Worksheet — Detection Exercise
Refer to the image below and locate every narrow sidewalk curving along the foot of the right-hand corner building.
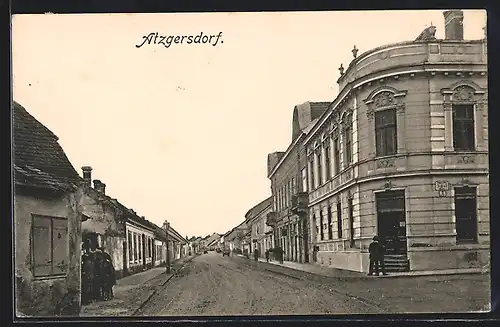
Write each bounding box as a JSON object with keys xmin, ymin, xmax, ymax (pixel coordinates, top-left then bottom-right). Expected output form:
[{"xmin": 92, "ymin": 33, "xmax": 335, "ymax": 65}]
[{"xmin": 246, "ymin": 258, "xmax": 489, "ymax": 278}]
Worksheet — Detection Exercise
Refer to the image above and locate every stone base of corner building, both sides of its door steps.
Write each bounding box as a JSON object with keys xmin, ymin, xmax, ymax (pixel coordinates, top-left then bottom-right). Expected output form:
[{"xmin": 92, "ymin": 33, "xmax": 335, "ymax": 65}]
[{"xmin": 316, "ymin": 245, "xmax": 490, "ymax": 273}]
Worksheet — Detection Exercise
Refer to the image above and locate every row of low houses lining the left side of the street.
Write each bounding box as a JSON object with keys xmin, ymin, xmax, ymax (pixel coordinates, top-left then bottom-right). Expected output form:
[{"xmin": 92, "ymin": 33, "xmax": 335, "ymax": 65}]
[{"xmin": 13, "ymin": 102, "xmax": 188, "ymax": 316}]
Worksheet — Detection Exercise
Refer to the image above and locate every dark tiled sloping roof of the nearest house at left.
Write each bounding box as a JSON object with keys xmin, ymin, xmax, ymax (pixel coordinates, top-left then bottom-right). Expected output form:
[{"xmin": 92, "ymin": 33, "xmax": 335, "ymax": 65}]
[{"xmin": 12, "ymin": 102, "xmax": 82, "ymax": 190}]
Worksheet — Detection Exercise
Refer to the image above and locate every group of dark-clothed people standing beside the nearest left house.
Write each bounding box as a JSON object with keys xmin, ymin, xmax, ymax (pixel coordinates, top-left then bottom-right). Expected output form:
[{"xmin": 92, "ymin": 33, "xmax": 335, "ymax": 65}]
[{"xmin": 82, "ymin": 241, "xmax": 116, "ymax": 305}]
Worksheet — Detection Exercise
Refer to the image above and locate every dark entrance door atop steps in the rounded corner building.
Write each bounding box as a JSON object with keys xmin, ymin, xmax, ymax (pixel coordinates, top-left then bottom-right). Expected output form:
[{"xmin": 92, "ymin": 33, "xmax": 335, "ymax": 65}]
[{"xmin": 377, "ymin": 191, "xmax": 407, "ymax": 255}]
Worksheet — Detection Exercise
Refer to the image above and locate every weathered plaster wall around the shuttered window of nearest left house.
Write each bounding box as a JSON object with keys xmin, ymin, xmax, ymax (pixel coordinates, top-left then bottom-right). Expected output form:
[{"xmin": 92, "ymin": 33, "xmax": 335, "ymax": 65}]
[{"xmin": 14, "ymin": 193, "xmax": 81, "ymax": 317}]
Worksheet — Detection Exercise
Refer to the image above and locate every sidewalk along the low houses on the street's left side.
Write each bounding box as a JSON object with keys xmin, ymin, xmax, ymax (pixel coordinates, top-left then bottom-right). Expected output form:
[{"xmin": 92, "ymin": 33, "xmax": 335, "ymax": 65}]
[{"xmin": 80, "ymin": 256, "xmax": 195, "ymax": 317}]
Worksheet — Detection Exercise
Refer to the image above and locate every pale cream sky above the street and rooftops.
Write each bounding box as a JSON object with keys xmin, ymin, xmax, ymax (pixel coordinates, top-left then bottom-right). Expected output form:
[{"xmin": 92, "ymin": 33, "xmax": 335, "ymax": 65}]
[{"xmin": 12, "ymin": 10, "xmax": 486, "ymax": 237}]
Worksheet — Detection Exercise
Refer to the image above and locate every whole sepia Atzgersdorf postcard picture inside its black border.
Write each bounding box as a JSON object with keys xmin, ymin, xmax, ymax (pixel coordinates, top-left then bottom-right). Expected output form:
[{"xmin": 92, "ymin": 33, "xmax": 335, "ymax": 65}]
[{"xmin": 11, "ymin": 9, "xmax": 491, "ymax": 319}]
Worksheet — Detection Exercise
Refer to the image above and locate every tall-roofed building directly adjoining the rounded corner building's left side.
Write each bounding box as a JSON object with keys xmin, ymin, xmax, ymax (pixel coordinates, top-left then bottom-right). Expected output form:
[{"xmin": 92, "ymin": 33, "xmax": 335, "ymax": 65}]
[{"xmin": 268, "ymin": 102, "xmax": 330, "ymax": 262}]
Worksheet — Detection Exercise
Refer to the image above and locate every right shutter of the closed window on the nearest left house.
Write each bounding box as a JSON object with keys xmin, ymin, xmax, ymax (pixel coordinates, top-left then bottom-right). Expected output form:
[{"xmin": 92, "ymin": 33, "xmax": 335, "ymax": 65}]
[{"xmin": 52, "ymin": 219, "xmax": 69, "ymax": 275}]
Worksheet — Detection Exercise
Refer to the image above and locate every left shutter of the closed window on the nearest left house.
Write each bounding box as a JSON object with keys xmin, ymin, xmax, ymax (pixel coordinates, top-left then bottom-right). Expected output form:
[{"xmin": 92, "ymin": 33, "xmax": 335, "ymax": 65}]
[{"xmin": 32, "ymin": 216, "xmax": 52, "ymax": 277}]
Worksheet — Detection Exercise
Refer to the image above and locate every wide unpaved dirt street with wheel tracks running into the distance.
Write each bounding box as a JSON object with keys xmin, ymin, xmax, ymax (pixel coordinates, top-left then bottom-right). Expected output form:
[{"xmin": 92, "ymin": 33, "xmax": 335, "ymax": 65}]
[{"xmin": 140, "ymin": 252, "xmax": 489, "ymax": 316}]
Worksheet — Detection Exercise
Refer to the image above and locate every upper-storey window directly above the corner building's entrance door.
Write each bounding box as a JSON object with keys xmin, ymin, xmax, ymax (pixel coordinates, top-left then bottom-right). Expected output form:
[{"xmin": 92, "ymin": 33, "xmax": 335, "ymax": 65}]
[{"xmin": 375, "ymin": 109, "xmax": 397, "ymax": 157}]
